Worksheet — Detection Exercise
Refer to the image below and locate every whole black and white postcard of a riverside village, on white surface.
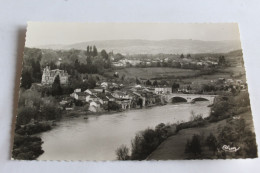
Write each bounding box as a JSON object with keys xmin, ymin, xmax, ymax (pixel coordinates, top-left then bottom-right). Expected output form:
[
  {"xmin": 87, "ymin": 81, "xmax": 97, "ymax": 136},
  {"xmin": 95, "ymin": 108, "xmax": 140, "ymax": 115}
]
[{"xmin": 12, "ymin": 22, "xmax": 258, "ymax": 161}]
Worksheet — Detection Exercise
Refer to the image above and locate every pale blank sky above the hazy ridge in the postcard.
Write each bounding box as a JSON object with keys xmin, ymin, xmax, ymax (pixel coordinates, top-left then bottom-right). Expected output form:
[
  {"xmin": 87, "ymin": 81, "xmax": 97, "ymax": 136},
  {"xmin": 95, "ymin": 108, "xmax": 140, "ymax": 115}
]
[{"xmin": 25, "ymin": 22, "xmax": 240, "ymax": 47}]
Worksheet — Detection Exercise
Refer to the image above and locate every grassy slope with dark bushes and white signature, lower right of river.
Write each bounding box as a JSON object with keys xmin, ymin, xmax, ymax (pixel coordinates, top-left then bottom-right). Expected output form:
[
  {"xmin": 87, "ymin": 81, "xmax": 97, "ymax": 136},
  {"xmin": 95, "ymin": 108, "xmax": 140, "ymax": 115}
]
[{"xmin": 147, "ymin": 93, "xmax": 257, "ymax": 160}]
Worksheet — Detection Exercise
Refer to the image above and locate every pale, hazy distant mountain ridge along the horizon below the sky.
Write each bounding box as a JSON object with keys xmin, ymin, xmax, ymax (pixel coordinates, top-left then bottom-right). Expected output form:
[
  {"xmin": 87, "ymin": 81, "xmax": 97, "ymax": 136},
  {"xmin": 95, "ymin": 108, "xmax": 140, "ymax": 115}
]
[{"xmin": 35, "ymin": 39, "xmax": 241, "ymax": 54}]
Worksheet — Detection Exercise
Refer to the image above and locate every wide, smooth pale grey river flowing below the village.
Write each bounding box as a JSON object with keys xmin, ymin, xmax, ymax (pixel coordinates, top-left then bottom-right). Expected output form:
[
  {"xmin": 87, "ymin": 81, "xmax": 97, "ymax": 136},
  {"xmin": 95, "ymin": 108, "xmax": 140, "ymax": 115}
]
[{"xmin": 38, "ymin": 101, "xmax": 210, "ymax": 160}]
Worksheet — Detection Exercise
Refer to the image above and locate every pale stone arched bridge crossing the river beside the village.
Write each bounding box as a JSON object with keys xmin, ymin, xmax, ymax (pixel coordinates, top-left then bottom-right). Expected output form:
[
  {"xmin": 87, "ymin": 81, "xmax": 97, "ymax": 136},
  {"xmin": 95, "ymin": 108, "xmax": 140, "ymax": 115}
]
[{"xmin": 164, "ymin": 93, "xmax": 216, "ymax": 104}]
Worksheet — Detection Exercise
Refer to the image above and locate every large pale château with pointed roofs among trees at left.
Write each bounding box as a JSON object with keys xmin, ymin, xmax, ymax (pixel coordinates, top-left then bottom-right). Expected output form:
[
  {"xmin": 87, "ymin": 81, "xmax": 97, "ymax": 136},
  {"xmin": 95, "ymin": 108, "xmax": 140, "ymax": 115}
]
[{"xmin": 42, "ymin": 66, "xmax": 69, "ymax": 85}]
